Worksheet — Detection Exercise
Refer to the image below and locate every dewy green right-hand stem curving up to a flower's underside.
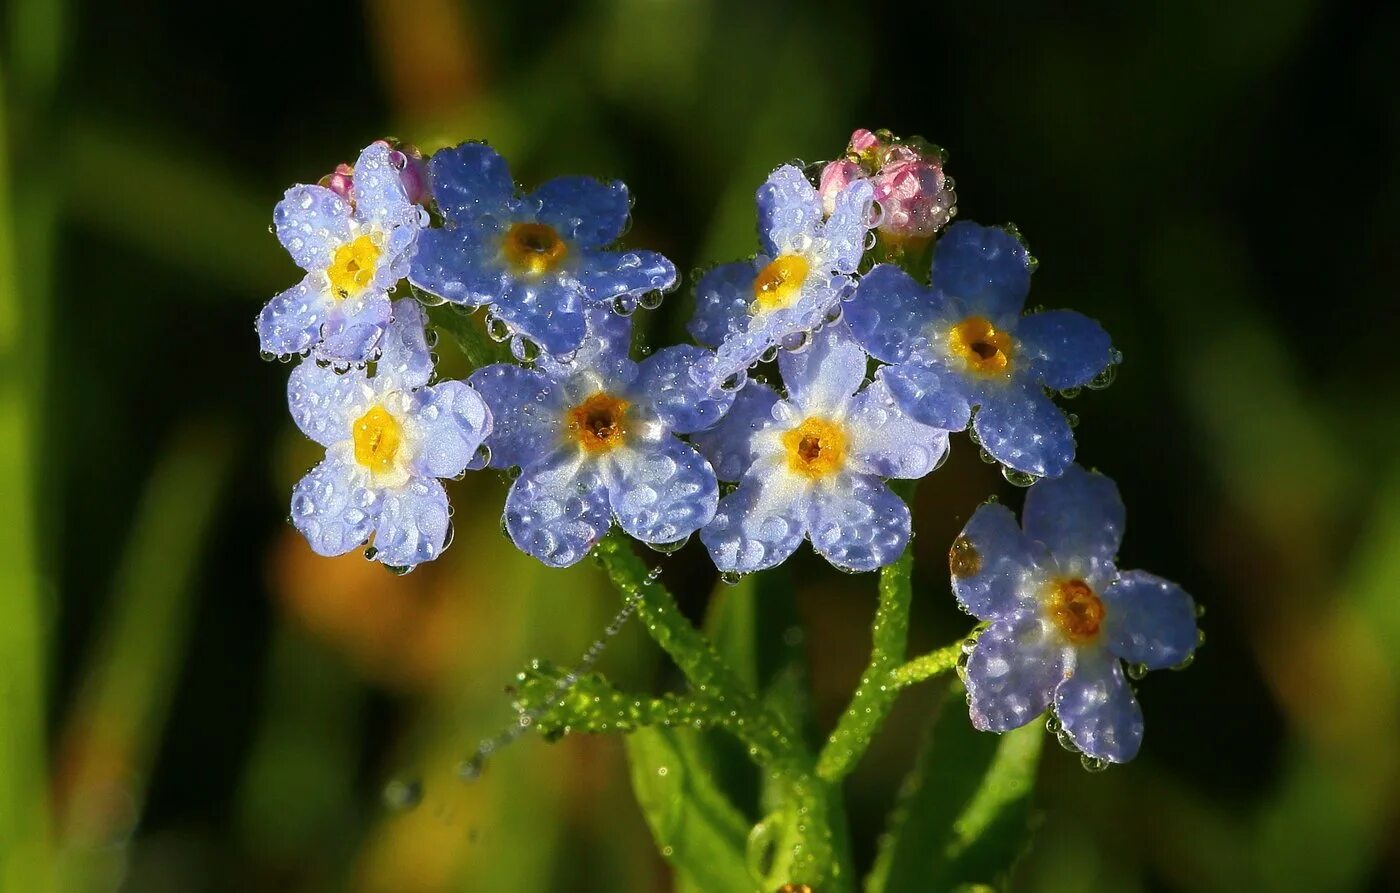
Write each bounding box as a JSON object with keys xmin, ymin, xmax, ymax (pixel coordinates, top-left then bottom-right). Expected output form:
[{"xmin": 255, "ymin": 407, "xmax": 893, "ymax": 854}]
[{"xmin": 816, "ymin": 549, "xmax": 914, "ymax": 782}]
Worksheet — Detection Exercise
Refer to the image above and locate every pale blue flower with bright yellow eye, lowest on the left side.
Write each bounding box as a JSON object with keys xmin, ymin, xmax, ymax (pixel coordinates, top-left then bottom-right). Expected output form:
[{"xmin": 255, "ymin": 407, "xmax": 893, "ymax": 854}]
[{"xmin": 287, "ymin": 296, "xmax": 491, "ymax": 567}]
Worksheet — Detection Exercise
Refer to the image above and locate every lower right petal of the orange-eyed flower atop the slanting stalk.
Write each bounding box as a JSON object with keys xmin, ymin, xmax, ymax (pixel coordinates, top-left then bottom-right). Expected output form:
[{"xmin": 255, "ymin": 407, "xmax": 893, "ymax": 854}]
[{"xmin": 608, "ymin": 437, "xmax": 720, "ymax": 543}]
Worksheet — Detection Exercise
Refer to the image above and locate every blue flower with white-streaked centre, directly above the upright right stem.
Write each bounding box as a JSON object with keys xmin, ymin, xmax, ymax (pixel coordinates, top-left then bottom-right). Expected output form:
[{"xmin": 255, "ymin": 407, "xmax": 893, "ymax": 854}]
[{"xmin": 693, "ymin": 322, "xmax": 948, "ymax": 572}]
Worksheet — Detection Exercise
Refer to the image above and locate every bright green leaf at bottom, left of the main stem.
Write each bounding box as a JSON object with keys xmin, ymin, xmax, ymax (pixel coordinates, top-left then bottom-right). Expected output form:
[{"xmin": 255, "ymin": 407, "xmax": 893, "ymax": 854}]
[{"xmin": 626, "ymin": 728, "xmax": 756, "ymax": 893}]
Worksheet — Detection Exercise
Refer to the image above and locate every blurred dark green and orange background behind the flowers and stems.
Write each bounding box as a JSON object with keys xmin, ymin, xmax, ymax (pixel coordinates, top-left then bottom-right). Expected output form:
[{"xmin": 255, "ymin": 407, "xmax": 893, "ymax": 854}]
[{"xmin": 0, "ymin": 0, "xmax": 1400, "ymax": 893}]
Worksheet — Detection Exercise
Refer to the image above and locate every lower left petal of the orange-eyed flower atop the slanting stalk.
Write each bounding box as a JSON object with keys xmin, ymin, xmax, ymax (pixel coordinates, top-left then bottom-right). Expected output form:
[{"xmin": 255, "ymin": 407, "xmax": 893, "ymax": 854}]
[{"xmin": 505, "ymin": 448, "xmax": 612, "ymax": 567}]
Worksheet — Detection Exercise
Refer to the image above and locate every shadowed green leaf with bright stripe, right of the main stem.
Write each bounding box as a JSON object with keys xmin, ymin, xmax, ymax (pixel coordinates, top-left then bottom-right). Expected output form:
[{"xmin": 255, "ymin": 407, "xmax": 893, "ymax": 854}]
[{"xmin": 865, "ymin": 686, "xmax": 1046, "ymax": 893}]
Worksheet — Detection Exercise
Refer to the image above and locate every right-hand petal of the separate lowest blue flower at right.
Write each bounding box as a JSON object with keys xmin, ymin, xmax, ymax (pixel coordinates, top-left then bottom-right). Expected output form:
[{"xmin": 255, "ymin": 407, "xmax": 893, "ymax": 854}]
[{"xmin": 1103, "ymin": 571, "xmax": 1197, "ymax": 669}]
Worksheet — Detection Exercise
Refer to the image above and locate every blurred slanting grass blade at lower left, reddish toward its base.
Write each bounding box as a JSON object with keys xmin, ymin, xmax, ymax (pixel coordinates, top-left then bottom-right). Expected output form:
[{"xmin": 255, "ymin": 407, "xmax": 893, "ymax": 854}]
[{"xmin": 56, "ymin": 424, "xmax": 232, "ymax": 890}]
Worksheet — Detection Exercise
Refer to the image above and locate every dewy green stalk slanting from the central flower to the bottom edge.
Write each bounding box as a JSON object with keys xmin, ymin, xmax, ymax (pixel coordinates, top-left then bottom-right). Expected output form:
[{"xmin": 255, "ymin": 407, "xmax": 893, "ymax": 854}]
[{"xmin": 594, "ymin": 530, "xmax": 853, "ymax": 893}]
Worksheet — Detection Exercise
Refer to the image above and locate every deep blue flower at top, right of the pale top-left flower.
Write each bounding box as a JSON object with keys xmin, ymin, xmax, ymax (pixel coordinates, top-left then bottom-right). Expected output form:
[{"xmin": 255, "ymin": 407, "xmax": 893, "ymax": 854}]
[{"xmin": 409, "ymin": 143, "xmax": 676, "ymax": 354}]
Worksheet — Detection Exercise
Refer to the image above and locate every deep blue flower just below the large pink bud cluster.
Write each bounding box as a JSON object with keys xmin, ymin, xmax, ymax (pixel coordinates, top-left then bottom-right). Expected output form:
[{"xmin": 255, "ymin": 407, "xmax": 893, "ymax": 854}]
[{"xmin": 844, "ymin": 223, "xmax": 1114, "ymax": 477}]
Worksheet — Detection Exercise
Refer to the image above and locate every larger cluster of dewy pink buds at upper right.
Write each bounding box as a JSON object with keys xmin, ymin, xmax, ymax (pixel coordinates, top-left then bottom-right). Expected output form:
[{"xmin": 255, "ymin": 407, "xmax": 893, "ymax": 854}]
[{"xmin": 820, "ymin": 129, "xmax": 958, "ymax": 248}]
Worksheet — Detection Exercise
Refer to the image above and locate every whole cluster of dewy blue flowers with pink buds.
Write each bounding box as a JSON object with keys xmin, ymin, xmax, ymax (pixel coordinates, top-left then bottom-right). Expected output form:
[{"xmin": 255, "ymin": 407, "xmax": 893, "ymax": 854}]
[{"xmin": 256, "ymin": 130, "xmax": 1196, "ymax": 760}]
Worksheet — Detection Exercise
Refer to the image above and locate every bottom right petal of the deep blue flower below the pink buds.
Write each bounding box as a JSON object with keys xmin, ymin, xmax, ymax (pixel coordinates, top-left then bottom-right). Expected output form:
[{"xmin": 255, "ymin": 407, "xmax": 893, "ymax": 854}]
[{"xmin": 973, "ymin": 382, "xmax": 1074, "ymax": 477}]
